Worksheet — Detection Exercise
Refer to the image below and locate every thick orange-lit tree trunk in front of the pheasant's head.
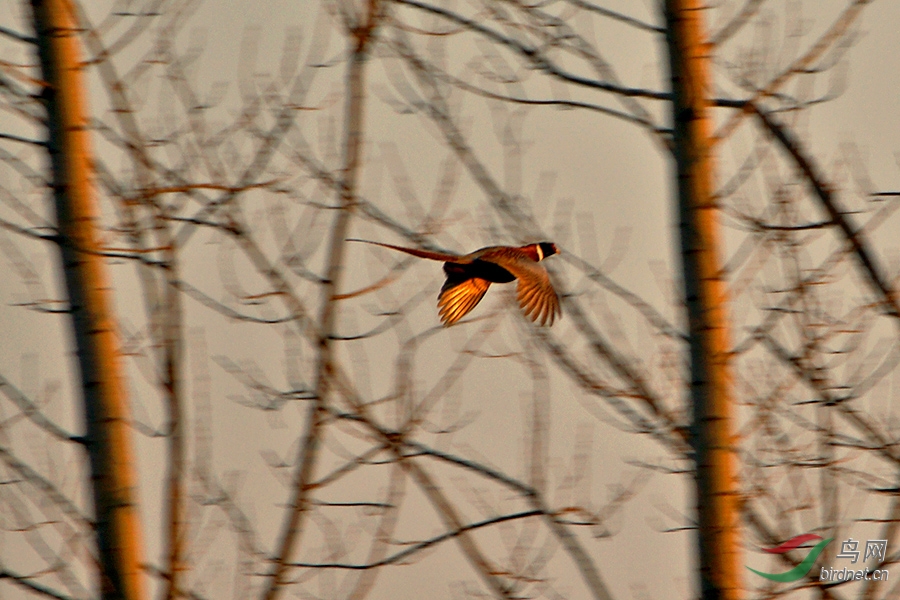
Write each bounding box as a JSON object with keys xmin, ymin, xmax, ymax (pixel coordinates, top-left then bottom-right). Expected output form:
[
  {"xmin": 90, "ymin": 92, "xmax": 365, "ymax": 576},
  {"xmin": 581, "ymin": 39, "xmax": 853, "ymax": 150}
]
[{"xmin": 665, "ymin": 0, "xmax": 741, "ymax": 600}]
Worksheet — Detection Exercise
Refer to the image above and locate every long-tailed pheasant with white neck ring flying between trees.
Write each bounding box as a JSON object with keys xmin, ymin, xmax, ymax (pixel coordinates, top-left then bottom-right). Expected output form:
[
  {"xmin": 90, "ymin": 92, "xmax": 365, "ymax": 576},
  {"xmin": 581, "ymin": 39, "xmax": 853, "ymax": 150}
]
[{"xmin": 347, "ymin": 239, "xmax": 562, "ymax": 327}]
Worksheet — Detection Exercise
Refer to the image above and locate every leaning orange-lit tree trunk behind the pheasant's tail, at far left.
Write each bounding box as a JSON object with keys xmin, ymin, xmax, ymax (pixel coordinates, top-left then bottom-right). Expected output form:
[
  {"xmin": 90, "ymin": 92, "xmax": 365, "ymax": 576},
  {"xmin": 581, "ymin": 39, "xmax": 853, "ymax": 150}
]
[{"xmin": 31, "ymin": 0, "xmax": 145, "ymax": 599}]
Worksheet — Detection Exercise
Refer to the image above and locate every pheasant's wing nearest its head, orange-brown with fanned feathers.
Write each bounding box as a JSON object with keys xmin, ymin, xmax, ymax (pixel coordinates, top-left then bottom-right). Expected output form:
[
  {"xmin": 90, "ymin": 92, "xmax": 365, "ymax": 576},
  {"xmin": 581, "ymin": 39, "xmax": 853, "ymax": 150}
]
[{"xmin": 480, "ymin": 249, "xmax": 562, "ymax": 325}]
